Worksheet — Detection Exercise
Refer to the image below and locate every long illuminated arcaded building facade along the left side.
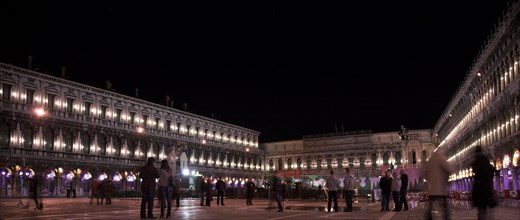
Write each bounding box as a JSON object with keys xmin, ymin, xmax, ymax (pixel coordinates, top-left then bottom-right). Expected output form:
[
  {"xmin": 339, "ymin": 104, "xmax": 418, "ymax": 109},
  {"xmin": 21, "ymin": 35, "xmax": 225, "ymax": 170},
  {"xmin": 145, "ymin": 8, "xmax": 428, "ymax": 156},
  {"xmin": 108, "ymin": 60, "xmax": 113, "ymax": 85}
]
[{"xmin": 0, "ymin": 63, "xmax": 265, "ymax": 197}]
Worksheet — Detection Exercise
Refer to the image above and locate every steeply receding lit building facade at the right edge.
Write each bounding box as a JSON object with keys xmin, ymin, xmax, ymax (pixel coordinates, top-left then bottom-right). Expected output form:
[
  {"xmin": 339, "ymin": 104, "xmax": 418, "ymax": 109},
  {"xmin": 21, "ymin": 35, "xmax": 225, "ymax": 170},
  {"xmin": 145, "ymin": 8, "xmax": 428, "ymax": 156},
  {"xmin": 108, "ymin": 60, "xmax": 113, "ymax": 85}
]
[{"xmin": 433, "ymin": 1, "xmax": 520, "ymax": 192}]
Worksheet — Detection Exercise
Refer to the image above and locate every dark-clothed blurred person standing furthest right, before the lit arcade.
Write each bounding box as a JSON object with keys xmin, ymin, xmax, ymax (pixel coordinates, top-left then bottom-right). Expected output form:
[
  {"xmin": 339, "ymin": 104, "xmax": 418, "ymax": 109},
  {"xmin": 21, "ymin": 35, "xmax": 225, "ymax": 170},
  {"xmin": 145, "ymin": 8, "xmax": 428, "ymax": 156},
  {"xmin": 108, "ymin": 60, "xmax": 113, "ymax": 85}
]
[{"xmin": 471, "ymin": 146, "xmax": 496, "ymax": 220}]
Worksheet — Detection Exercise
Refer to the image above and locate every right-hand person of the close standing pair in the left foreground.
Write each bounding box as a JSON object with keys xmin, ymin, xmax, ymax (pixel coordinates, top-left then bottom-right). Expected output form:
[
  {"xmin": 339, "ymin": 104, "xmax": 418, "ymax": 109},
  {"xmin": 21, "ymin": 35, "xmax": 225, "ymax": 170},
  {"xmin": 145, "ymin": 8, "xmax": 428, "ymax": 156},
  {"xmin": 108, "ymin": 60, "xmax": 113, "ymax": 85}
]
[{"xmin": 158, "ymin": 159, "xmax": 175, "ymax": 218}]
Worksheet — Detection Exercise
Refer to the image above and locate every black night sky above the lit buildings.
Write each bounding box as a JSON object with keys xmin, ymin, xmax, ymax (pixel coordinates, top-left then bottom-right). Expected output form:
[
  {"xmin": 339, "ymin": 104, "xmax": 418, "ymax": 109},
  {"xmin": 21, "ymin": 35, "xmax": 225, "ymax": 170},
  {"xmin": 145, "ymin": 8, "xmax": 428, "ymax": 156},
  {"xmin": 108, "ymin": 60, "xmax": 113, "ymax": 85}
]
[{"xmin": 0, "ymin": 0, "xmax": 506, "ymax": 142}]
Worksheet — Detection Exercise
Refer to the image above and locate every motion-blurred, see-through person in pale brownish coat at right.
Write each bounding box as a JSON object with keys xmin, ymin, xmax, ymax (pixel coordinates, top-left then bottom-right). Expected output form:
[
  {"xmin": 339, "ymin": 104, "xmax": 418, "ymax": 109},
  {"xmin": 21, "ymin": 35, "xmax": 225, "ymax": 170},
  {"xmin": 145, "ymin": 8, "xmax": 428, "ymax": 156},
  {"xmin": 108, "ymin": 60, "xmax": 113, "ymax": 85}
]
[{"xmin": 424, "ymin": 148, "xmax": 453, "ymax": 220}]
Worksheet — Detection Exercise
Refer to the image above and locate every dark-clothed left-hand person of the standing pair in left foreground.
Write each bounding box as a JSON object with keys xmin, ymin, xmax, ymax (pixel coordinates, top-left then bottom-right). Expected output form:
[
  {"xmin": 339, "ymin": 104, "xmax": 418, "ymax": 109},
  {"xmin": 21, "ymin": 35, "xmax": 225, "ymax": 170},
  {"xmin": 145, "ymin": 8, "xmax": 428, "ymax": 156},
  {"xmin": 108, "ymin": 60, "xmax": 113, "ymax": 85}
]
[{"xmin": 139, "ymin": 157, "xmax": 159, "ymax": 218}]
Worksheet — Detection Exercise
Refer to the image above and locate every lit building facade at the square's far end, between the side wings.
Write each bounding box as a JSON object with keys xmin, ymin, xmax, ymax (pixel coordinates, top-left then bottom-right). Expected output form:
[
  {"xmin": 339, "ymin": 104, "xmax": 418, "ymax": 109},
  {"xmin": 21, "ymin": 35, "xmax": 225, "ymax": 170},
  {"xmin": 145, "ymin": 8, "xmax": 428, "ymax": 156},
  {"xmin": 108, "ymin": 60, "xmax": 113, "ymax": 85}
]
[{"xmin": 261, "ymin": 127, "xmax": 435, "ymax": 190}]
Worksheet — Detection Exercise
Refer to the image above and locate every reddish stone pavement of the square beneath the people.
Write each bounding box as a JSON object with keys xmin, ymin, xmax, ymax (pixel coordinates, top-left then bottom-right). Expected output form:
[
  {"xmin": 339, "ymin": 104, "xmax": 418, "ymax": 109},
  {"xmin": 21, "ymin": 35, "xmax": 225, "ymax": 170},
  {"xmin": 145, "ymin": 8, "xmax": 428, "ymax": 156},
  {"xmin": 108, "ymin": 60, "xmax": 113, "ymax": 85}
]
[{"xmin": 0, "ymin": 198, "xmax": 520, "ymax": 220}]
